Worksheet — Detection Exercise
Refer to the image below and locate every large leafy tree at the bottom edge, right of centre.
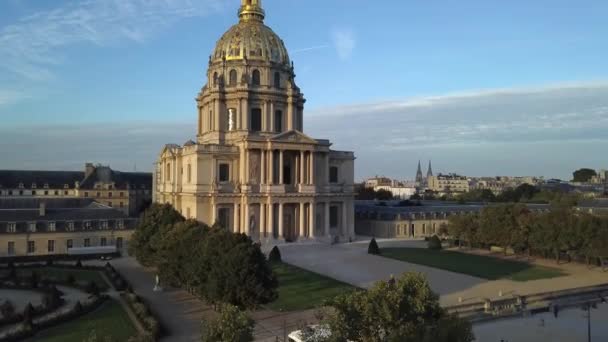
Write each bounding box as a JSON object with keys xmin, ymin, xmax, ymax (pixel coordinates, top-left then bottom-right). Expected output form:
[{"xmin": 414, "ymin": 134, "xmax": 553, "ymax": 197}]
[{"xmin": 326, "ymin": 273, "xmax": 474, "ymax": 342}]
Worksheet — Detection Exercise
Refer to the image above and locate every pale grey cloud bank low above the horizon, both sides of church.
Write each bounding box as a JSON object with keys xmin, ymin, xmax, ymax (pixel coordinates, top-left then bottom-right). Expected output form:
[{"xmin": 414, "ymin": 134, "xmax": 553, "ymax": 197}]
[{"xmin": 0, "ymin": 82, "xmax": 608, "ymax": 178}]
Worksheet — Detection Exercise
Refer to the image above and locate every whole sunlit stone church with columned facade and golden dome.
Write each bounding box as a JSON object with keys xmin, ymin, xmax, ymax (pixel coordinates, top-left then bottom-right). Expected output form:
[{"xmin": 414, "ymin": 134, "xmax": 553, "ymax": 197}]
[{"xmin": 153, "ymin": 0, "xmax": 355, "ymax": 242}]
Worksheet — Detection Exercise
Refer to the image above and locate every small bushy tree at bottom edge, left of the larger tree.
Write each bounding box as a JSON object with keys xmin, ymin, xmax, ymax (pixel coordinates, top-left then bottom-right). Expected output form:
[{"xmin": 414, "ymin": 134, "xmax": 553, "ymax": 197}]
[{"xmin": 201, "ymin": 305, "xmax": 254, "ymax": 342}]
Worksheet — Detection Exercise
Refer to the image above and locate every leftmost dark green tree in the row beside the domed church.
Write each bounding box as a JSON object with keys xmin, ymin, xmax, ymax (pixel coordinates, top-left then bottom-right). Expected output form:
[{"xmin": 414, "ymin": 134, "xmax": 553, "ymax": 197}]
[{"xmin": 129, "ymin": 203, "xmax": 185, "ymax": 266}]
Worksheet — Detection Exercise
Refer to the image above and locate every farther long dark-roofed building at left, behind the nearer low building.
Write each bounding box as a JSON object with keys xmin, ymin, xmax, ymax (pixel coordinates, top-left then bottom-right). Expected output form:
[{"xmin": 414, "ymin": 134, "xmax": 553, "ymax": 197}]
[{"xmin": 0, "ymin": 163, "xmax": 152, "ymax": 216}]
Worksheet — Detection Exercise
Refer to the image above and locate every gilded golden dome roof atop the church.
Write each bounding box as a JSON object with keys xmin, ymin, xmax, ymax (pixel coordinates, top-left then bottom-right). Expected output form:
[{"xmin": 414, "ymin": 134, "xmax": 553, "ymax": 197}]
[{"xmin": 211, "ymin": 0, "xmax": 289, "ymax": 66}]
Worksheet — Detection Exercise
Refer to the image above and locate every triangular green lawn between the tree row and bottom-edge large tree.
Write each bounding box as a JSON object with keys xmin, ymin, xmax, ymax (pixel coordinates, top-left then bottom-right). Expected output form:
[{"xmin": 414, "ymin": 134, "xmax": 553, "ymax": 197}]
[{"xmin": 268, "ymin": 263, "xmax": 355, "ymax": 311}]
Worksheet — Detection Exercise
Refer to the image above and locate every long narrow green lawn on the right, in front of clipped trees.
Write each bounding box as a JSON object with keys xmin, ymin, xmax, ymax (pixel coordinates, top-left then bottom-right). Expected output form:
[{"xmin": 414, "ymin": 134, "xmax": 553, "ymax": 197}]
[{"xmin": 381, "ymin": 248, "xmax": 567, "ymax": 281}]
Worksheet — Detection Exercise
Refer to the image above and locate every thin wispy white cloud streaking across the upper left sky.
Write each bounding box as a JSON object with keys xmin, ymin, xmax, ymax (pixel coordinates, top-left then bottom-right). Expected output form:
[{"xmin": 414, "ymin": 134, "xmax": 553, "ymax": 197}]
[{"xmin": 0, "ymin": 0, "xmax": 223, "ymax": 81}]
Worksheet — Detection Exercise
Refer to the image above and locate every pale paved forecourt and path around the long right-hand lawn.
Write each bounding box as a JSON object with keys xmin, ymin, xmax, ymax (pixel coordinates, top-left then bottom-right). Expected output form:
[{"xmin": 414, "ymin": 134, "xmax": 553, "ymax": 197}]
[{"xmin": 279, "ymin": 240, "xmax": 608, "ymax": 306}]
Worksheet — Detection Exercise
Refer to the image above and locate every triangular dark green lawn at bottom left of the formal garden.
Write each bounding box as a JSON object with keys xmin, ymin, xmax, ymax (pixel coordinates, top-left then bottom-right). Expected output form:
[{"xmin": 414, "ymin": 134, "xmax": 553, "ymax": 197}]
[{"xmin": 33, "ymin": 300, "xmax": 137, "ymax": 342}]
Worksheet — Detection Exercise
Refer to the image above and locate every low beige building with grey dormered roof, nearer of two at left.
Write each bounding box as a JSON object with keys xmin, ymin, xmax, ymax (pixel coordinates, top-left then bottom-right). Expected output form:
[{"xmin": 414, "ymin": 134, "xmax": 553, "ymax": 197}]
[{"xmin": 0, "ymin": 196, "xmax": 137, "ymax": 257}]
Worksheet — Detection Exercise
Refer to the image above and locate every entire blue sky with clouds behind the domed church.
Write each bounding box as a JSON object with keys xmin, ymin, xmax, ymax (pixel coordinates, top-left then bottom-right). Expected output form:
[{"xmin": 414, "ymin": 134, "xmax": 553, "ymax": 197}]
[{"xmin": 0, "ymin": 0, "xmax": 608, "ymax": 178}]
